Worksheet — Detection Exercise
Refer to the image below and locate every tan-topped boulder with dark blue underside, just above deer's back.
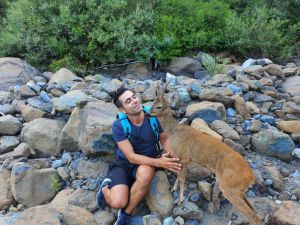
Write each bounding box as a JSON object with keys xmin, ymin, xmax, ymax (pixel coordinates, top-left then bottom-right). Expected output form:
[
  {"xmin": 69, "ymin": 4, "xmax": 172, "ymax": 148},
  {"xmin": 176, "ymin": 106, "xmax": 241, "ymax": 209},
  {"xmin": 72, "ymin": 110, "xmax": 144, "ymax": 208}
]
[{"xmin": 186, "ymin": 101, "xmax": 226, "ymax": 124}]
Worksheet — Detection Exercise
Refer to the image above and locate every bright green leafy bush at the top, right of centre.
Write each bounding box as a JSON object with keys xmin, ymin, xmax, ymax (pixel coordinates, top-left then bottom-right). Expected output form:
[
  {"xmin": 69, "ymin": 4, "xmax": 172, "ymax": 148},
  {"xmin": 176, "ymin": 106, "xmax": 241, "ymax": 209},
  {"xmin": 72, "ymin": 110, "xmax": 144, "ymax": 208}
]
[{"xmin": 154, "ymin": 0, "xmax": 231, "ymax": 60}]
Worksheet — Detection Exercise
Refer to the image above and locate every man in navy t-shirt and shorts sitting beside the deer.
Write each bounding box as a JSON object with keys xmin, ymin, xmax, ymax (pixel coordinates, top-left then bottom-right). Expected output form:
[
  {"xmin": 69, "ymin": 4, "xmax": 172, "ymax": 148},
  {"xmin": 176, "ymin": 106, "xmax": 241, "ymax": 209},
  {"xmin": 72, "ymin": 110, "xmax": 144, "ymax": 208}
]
[{"xmin": 97, "ymin": 87, "xmax": 181, "ymax": 225}]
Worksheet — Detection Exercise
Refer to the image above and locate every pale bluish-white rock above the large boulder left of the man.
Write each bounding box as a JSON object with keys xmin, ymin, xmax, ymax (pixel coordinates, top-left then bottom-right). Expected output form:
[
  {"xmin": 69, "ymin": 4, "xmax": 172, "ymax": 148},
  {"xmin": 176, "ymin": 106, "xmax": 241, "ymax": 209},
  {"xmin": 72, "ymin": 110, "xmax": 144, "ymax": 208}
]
[{"xmin": 52, "ymin": 90, "xmax": 87, "ymax": 113}]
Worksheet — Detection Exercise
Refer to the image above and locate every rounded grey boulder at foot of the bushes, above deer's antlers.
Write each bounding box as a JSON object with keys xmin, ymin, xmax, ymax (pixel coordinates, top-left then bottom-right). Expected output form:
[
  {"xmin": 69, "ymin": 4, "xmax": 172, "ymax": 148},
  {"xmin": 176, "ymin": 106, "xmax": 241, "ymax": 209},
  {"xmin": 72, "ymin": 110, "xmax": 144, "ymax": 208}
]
[{"xmin": 167, "ymin": 57, "xmax": 202, "ymax": 77}]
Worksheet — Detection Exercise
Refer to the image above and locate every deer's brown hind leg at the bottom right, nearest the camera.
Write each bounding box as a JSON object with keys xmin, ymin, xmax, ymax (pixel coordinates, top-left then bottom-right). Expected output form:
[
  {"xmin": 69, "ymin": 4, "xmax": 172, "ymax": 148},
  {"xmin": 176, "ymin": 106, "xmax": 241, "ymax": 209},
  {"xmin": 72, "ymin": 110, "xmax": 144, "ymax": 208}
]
[{"xmin": 222, "ymin": 190, "xmax": 262, "ymax": 225}]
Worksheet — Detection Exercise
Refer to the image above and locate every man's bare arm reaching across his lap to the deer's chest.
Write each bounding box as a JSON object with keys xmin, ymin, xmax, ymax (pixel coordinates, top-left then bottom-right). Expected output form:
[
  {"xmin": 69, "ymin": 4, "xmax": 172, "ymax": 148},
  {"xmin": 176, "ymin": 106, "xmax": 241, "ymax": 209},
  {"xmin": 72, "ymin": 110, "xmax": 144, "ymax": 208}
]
[{"xmin": 117, "ymin": 139, "xmax": 181, "ymax": 174}]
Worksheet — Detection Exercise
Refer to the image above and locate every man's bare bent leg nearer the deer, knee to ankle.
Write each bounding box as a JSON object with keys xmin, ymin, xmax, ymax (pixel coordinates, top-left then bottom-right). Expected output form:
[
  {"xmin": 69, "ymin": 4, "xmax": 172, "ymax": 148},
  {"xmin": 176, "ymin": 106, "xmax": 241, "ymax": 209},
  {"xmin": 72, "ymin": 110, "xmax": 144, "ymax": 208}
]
[{"xmin": 125, "ymin": 165, "xmax": 155, "ymax": 214}]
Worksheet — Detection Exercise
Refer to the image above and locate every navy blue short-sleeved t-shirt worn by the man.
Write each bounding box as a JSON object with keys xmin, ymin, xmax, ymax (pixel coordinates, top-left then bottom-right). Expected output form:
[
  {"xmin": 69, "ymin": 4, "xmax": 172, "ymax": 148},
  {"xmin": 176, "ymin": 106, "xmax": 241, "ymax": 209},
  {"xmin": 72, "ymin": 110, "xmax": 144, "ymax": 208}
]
[{"xmin": 112, "ymin": 117, "xmax": 163, "ymax": 158}]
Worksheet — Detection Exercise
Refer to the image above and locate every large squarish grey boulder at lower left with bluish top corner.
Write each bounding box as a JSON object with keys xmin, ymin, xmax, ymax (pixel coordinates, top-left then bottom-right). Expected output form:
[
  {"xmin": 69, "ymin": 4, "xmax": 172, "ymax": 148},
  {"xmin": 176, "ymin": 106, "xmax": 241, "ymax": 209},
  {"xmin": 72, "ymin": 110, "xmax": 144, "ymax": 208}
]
[{"xmin": 11, "ymin": 163, "xmax": 57, "ymax": 207}]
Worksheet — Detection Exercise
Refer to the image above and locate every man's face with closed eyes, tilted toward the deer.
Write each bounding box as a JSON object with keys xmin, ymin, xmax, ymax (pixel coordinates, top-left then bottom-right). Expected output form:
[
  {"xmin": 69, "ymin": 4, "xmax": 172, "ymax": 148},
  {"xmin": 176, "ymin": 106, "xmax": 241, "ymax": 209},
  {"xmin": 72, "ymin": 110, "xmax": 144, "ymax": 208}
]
[{"xmin": 119, "ymin": 91, "xmax": 143, "ymax": 115}]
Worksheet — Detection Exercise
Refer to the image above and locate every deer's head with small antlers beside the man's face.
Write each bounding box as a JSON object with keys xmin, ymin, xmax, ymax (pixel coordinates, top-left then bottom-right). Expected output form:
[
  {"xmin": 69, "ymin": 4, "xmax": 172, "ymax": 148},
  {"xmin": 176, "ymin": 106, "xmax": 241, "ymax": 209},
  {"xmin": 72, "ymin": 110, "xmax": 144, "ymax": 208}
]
[{"xmin": 150, "ymin": 81, "xmax": 170, "ymax": 117}]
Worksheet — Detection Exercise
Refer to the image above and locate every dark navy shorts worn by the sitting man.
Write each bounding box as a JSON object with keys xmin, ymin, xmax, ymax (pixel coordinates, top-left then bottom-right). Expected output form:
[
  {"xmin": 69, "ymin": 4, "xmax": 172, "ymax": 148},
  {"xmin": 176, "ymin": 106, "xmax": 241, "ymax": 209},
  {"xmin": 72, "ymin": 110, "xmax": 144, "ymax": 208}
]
[{"xmin": 108, "ymin": 159, "xmax": 139, "ymax": 189}]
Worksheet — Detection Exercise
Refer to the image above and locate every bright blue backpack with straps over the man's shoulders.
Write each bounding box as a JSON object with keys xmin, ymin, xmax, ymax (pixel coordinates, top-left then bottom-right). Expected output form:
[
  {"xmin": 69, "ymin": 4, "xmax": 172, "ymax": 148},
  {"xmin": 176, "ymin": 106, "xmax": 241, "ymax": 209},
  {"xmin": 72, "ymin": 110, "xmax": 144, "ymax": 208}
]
[{"xmin": 117, "ymin": 106, "xmax": 160, "ymax": 159}]
